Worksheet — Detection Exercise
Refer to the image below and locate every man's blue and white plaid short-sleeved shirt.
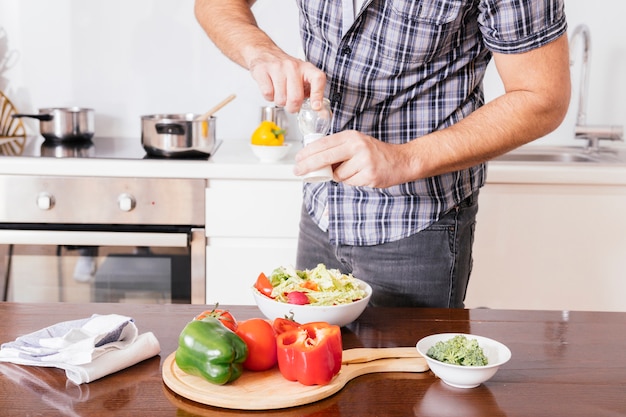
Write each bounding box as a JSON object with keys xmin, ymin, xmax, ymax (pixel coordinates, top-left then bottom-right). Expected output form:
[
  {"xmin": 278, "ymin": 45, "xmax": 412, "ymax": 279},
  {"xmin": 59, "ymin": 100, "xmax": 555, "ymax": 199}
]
[{"xmin": 297, "ymin": 0, "xmax": 567, "ymax": 246}]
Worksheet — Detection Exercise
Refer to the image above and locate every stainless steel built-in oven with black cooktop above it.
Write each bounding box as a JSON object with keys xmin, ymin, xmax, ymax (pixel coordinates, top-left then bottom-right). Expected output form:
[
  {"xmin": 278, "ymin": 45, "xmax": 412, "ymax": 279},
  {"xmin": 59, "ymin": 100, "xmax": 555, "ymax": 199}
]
[{"xmin": 0, "ymin": 138, "xmax": 206, "ymax": 304}]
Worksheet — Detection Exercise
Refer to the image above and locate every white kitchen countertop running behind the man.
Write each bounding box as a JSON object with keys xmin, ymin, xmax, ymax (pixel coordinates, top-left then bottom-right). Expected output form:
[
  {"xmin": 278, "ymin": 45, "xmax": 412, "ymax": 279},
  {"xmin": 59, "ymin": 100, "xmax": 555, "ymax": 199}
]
[{"xmin": 0, "ymin": 139, "xmax": 626, "ymax": 185}]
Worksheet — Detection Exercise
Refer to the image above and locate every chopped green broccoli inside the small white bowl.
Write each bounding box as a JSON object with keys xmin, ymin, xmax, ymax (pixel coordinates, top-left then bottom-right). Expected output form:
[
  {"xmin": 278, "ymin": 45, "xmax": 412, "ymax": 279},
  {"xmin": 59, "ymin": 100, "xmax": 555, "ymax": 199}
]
[{"xmin": 426, "ymin": 335, "xmax": 488, "ymax": 366}]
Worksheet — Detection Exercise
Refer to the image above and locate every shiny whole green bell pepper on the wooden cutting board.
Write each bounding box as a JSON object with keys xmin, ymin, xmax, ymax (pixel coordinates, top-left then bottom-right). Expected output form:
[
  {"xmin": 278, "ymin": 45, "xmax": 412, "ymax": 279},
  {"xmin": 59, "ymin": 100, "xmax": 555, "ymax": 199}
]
[{"xmin": 175, "ymin": 317, "xmax": 248, "ymax": 385}]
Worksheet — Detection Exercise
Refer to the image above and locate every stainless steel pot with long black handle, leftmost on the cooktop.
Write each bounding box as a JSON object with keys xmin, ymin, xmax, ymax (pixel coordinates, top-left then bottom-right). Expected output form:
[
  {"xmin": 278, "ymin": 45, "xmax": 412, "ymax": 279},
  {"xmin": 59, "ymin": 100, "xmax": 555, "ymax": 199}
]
[{"xmin": 13, "ymin": 107, "xmax": 95, "ymax": 142}]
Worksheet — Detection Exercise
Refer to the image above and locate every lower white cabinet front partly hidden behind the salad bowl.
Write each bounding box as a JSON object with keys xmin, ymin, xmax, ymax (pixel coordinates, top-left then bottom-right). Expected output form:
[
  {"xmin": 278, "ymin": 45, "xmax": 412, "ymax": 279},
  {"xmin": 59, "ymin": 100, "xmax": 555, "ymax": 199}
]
[{"xmin": 206, "ymin": 238, "xmax": 297, "ymax": 305}]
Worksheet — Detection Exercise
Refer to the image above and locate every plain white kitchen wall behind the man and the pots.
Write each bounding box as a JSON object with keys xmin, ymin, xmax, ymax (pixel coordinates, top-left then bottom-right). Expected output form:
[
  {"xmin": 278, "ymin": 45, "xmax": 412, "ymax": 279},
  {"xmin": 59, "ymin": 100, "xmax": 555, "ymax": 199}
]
[{"xmin": 0, "ymin": 0, "xmax": 626, "ymax": 147}]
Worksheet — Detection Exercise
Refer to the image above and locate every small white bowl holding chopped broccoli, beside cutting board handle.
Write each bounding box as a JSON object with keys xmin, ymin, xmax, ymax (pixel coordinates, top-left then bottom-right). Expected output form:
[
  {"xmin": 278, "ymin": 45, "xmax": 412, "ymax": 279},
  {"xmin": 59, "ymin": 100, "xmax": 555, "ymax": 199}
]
[{"xmin": 416, "ymin": 333, "xmax": 511, "ymax": 388}]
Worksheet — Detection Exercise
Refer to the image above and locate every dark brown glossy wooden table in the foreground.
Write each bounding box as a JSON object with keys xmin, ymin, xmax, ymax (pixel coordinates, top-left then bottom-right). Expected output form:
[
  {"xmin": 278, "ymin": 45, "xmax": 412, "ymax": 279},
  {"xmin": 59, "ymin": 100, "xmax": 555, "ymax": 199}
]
[{"xmin": 0, "ymin": 303, "xmax": 626, "ymax": 417}]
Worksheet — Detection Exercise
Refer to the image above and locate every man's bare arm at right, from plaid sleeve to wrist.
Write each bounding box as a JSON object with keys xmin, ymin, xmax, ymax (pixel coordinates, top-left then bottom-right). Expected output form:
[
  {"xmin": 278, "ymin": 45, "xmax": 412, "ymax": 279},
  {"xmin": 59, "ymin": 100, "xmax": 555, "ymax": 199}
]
[{"xmin": 400, "ymin": 35, "xmax": 570, "ymax": 183}]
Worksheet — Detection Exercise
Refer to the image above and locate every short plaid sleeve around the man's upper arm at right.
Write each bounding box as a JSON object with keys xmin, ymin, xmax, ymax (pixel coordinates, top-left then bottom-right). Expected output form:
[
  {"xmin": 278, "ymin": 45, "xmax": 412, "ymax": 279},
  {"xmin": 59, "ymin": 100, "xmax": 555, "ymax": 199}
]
[{"xmin": 478, "ymin": 0, "xmax": 567, "ymax": 54}]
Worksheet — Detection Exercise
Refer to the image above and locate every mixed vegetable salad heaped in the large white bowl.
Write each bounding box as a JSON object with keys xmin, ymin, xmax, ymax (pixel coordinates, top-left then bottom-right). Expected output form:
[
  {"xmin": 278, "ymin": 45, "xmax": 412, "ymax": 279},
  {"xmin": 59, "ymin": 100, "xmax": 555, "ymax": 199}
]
[{"xmin": 258, "ymin": 264, "xmax": 367, "ymax": 306}]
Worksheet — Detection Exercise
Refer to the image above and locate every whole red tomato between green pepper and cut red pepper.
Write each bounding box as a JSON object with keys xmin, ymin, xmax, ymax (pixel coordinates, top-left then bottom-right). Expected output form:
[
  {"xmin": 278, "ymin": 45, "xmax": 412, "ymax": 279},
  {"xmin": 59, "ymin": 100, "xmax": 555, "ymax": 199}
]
[{"xmin": 236, "ymin": 318, "xmax": 278, "ymax": 371}]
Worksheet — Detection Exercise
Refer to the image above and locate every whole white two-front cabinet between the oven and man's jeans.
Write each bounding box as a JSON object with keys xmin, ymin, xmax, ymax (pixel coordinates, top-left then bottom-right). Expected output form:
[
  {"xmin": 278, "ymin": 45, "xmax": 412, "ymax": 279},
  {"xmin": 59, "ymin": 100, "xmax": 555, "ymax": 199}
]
[{"xmin": 206, "ymin": 179, "xmax": 302, "ymax": 304}]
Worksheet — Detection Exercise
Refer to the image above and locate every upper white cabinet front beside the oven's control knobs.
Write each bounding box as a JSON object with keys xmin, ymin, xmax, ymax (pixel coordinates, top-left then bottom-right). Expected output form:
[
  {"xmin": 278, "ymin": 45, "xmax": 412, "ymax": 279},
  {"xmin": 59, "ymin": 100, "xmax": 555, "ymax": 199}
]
[{"xmin": 206, "ymin": 180, "xmax": 302, "ymax": 238}]
